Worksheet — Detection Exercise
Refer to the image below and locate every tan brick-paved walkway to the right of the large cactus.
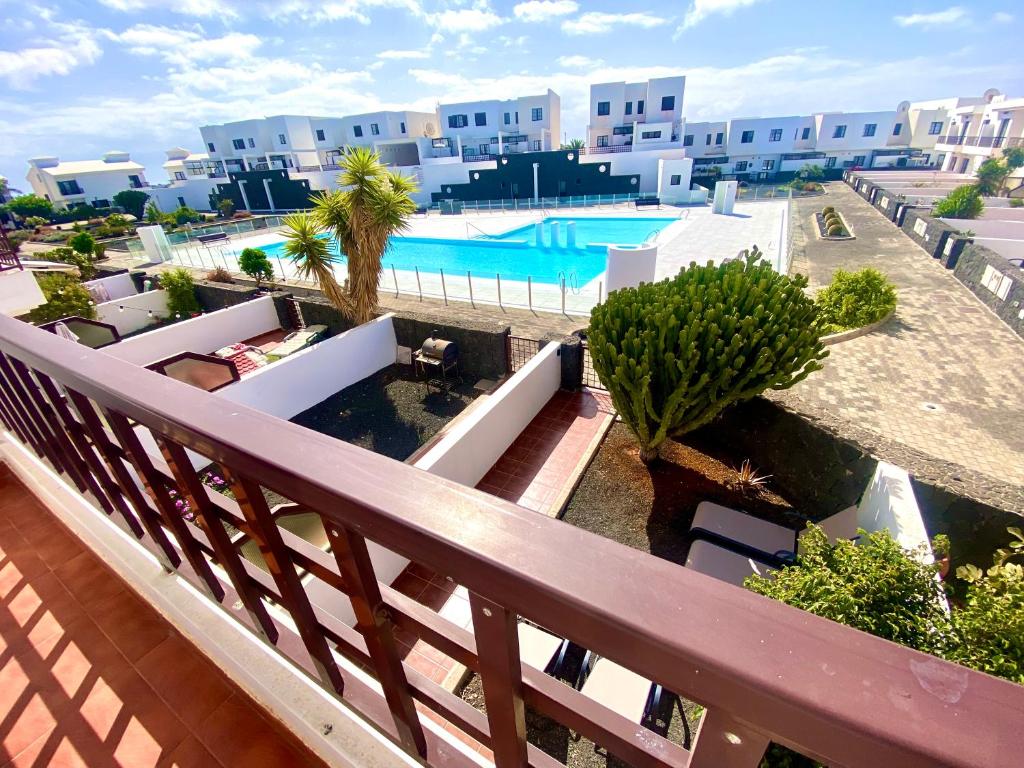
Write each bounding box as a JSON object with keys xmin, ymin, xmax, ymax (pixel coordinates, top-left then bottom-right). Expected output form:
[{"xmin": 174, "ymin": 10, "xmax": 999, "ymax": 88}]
[{"xmin": 784, "ymin": 182, "xmax": 1024, "ymax": 484}]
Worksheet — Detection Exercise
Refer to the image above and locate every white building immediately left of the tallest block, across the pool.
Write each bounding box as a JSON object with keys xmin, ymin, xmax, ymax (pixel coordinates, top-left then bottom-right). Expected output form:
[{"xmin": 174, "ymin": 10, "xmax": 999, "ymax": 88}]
[{"xmin": 436, "ymin": 88, "xmax": 562, "ymax": 160}]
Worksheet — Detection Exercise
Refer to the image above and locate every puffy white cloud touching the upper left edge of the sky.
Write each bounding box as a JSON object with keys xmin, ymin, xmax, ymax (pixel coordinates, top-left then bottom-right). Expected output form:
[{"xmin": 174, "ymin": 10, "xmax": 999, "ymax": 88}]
[{"xmin": 0, "ymin": 19, "xmax": 103, "ymax": 90}]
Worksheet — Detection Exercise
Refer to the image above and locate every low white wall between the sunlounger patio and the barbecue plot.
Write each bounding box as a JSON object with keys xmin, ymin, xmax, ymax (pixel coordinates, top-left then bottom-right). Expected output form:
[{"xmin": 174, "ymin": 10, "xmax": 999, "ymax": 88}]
[{"xmin": 222, "ymin": 314, "xmax": 398, "ymax": 419}]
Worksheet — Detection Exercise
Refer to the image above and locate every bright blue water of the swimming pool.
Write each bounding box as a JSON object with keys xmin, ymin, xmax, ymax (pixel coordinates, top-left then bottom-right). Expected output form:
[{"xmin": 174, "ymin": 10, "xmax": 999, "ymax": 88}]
[{"xmin": 247, "ymin": 217, "xmax": 672, "ymax": 285}]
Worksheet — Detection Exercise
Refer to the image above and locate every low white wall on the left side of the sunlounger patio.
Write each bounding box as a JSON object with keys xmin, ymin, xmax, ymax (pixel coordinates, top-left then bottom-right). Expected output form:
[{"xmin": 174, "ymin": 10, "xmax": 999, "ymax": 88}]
[{"xmin": 102, "ymin": 294, "xmax": 281, "ymax": 366}]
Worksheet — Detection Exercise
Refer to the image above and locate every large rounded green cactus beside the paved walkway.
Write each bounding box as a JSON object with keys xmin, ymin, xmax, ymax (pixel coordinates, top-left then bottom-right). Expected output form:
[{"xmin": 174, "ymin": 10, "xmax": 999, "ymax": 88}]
[{"xmin": 588, "ymin": 246, "xmax": 827, "ymax": 462}]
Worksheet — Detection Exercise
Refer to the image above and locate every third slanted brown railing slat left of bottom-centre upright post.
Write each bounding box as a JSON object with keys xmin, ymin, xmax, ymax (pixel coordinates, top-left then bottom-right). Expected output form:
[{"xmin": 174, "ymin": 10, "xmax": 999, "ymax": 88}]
[{"xmin": 154, "ymin": 434, "xmax": 278, "ymax": 643}]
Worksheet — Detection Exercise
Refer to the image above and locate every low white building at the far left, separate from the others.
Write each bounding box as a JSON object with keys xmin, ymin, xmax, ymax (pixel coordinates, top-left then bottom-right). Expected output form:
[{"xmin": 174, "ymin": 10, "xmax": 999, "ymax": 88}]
[{"xmin": 26, "ymin": 152, "xmax": 146, "ymax": 208}]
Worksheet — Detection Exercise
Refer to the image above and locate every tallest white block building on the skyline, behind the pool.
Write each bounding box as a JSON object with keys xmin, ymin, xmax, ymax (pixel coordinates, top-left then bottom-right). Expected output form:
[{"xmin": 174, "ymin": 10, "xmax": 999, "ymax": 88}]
[{"xmin": 587, "ymin": 76, "xmax": 686, "ymax": 154}]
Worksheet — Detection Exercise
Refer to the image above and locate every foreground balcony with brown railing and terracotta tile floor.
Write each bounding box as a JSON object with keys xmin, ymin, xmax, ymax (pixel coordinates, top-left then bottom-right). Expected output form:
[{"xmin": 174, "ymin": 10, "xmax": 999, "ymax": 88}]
[{"xmin": 0, "ymin": 317, "xmax": 1024, "ymax": 768}]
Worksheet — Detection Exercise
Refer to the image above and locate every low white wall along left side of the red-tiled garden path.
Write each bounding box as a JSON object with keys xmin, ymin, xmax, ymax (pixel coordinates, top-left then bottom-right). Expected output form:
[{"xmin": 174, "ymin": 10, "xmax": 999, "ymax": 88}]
[{"xmin": 415, "ymin": 344, "xmax": 561, "ymax": 486}]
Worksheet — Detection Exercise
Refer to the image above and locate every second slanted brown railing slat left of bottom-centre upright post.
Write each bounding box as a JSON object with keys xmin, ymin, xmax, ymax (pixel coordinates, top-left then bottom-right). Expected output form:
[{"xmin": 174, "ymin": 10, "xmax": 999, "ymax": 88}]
[{"xmin": 222, "ymin": 467, "xmax": 345, "ymax": 693}]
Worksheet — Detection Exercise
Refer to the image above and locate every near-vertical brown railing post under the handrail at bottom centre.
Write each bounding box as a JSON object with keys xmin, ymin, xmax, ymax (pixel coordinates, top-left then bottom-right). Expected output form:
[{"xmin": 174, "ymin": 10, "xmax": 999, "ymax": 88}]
[{"xmin": 469, "ymin": 592, "xmax": 526, "ymax": 768}]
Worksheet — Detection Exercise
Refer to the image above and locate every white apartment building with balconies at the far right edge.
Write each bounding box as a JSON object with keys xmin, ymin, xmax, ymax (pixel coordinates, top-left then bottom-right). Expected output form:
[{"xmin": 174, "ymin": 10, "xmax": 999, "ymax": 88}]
[{"xmin": 935, "ymin": 88, "xmax": 1024, "ymax": 177}]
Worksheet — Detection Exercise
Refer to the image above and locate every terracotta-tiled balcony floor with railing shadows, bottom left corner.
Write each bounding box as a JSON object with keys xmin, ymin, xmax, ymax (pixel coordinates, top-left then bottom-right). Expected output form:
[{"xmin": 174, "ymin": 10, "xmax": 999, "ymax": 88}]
[{"xmin": 0, "ymin": 464, "xmax": 324, "ymax": 768}]
